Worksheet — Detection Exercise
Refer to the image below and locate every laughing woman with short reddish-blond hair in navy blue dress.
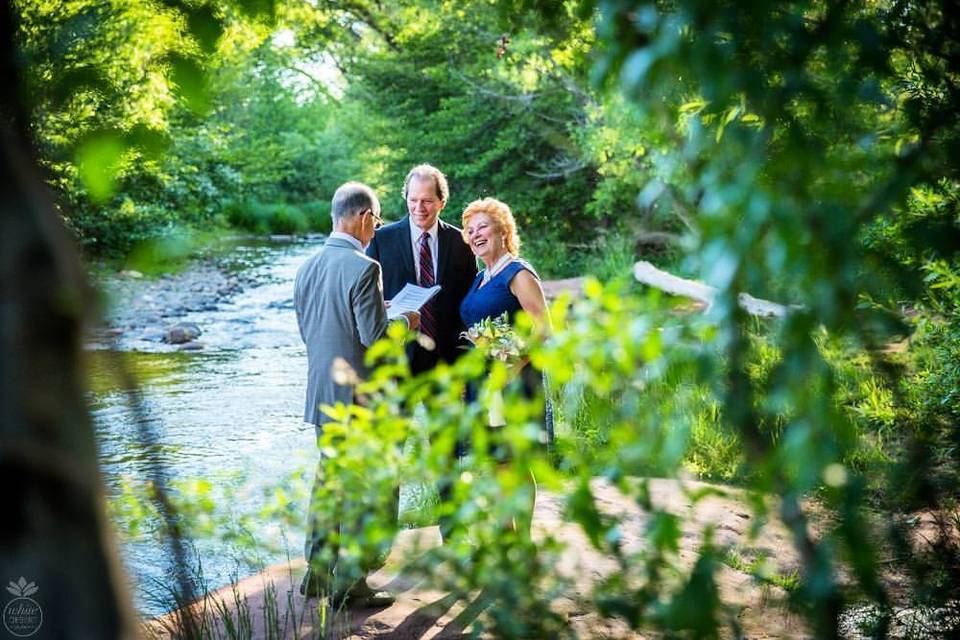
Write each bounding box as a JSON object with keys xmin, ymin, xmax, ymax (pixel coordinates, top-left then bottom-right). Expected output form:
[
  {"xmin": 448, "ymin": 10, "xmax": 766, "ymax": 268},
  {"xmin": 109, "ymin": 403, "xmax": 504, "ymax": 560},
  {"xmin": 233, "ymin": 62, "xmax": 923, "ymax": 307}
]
[{"xmin": 460, "ymin": 198, "xmax": 553, "ymax": 535}]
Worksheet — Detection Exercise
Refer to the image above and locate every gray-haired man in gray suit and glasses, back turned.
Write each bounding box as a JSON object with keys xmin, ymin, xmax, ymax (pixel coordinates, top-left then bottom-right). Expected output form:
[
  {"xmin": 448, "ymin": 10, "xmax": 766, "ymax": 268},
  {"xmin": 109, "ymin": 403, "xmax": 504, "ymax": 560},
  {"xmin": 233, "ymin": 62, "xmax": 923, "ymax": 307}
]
[{"xmin": 293, "ymin": 182, "xmax": 420, "ymax": 606}]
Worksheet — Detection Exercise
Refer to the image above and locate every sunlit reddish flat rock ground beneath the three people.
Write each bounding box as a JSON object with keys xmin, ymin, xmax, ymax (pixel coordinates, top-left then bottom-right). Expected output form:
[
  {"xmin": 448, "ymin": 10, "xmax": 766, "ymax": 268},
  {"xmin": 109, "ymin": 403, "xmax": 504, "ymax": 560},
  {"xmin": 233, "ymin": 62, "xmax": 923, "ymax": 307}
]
[{"xmin": 148, "ymin": 479, "xmax": 809, "ymax": 638}]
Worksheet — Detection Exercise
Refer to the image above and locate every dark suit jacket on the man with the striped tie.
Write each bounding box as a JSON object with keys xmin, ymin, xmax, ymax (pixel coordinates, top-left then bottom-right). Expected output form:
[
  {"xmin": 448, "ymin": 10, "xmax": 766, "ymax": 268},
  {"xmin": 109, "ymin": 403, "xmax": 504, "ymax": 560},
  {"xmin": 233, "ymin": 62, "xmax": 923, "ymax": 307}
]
[{"xmin": 367, "ymin": 216, "xmax": 477, "ymax": 374}]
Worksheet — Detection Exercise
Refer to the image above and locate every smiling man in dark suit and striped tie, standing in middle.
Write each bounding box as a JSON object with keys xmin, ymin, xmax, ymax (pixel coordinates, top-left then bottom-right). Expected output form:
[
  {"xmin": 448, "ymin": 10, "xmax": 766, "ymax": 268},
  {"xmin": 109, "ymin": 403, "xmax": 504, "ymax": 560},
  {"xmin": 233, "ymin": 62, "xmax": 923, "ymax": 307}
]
[{"xmin": 367, "ymin": 164, "xmax": 477, "ymax": 375}]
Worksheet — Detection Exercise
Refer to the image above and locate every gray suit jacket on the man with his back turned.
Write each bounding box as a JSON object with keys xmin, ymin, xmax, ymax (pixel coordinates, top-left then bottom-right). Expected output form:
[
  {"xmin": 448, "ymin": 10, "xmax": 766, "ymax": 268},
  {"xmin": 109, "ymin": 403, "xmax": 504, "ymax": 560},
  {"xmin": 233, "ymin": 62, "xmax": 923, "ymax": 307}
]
[{"xmin": 293, "ymin": 238, "xmax": 387, "ymax": 426}]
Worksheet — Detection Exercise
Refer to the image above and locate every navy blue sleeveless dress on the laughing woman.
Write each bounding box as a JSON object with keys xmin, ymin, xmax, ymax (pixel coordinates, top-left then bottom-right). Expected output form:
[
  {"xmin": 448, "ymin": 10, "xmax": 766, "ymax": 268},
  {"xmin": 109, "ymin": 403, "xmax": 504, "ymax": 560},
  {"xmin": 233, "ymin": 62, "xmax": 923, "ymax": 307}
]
[{"xmin": 460, "ymin": 259, "xmax": 553, "ymax": 443}]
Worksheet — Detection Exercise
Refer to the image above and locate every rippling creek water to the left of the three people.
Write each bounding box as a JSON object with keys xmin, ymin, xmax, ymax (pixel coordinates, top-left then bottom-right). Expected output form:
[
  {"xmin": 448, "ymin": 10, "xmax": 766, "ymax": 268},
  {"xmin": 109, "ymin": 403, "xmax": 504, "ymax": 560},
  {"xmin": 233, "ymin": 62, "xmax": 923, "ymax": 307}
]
[{"xmin": 88, "ymin": 239, "xmax": 319, "ymax": 615}]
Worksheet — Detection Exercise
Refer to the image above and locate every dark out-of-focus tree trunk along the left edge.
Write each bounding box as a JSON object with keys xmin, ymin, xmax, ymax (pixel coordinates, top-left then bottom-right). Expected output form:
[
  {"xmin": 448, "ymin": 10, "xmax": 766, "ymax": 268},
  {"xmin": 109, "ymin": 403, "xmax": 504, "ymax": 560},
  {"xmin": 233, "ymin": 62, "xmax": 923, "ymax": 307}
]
[{"xmin": 0, "ymin": 3, "xmax": 136, "ymax": 638}]
